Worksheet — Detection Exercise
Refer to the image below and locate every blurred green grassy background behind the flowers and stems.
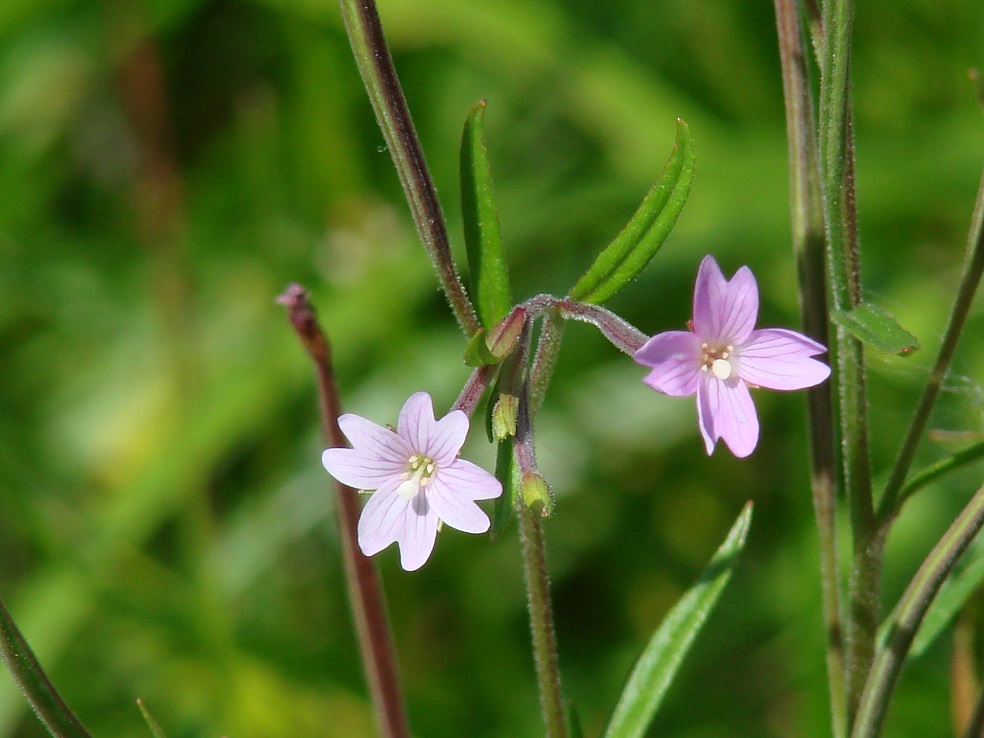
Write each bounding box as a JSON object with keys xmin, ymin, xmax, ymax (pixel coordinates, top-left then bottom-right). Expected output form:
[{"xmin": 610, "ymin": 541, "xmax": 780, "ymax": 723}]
[{"xmin": 0, "ymin": 0, "xmax": 984, "ymax": 738}]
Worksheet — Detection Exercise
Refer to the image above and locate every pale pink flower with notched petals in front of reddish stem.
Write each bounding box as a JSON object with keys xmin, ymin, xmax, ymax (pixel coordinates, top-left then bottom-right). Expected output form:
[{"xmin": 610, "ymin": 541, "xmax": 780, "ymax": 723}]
[{"xmin": 321, "ymin": 392, "xmax": 502, "ymax": 571}]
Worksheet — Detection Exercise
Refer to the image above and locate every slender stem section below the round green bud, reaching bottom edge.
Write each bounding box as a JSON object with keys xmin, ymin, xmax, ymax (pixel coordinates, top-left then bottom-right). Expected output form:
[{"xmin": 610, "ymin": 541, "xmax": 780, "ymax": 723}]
[{"xmin": 517, "ymin": 500, "xmax": 567, "ymax": 738}]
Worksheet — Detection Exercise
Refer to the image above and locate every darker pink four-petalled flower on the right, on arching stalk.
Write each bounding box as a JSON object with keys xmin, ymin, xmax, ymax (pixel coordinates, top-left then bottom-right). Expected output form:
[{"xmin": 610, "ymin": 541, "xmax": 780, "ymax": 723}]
[{"xmin": 635, "ymin": 256, "xmax": 830, "ymax": 458}]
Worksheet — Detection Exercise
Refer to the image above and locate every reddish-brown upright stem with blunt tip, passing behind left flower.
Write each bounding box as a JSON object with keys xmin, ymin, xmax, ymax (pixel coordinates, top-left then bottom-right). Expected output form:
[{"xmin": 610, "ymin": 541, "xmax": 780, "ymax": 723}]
[{"xmin": 279, "ymin": 285, "xmax": 410, "ymax": 738}]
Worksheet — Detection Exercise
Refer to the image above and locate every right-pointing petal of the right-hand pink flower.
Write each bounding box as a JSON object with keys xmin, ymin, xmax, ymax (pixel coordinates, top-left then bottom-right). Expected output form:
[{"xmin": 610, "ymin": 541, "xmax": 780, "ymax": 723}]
[{"xmin": 737, "ymin": 328, "xmax": 830, "ymax": 390}]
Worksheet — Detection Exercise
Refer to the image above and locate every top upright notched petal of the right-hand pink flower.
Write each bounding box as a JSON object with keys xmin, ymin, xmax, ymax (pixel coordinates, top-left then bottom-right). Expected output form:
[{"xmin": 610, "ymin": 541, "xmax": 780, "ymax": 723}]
[{"xmin": 694, "ymin": 256, "xmax": 759, "ymax": 344}]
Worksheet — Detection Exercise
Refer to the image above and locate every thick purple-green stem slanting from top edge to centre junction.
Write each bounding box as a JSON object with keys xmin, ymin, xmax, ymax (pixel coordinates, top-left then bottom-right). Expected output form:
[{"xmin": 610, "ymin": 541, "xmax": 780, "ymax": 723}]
[{"xmin": 341, "ymin": 0, "xmax": 481, "ymax": 337}]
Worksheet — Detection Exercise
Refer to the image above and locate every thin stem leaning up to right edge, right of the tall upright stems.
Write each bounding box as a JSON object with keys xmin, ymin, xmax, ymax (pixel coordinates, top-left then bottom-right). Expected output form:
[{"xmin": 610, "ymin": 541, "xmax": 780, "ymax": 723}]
[{"xmin": 878, "ymin": 170, "xmax": 984, "ymax": 522}]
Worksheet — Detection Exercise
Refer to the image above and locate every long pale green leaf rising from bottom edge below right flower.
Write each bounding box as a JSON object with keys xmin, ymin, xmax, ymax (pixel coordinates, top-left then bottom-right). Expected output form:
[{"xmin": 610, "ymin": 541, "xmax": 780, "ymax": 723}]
[{"xmin": 605, "ymin": 502, "xmax": 752, "ymax": 738}]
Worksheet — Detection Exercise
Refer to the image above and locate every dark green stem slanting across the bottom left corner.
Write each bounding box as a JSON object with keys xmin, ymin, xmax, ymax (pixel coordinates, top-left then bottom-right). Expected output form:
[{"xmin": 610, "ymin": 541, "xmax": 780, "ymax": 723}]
[{"xmin": 0, "ymin": 602, "xmax": 91, "ymax": 738}]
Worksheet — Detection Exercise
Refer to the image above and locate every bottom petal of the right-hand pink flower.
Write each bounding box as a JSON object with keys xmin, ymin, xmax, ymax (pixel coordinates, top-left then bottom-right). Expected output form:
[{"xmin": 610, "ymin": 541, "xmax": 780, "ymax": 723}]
[{"xmin": 697, "ymin": 374, "xmax": 759, "ymax": 459}]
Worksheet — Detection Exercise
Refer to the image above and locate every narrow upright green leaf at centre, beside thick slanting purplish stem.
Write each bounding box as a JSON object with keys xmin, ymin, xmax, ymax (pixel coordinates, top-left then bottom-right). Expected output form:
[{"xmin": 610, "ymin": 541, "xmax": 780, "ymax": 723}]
[{"xmin": 461, "ymin": 100, "xmax": 512, "ymax": 328}]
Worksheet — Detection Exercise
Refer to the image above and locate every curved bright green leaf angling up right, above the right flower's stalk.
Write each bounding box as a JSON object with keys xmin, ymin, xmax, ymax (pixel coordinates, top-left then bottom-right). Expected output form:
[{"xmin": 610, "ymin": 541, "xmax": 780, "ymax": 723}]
[{"xmin": 570, "ymin": 118, "xmax": 694, "ymax": 305}]
